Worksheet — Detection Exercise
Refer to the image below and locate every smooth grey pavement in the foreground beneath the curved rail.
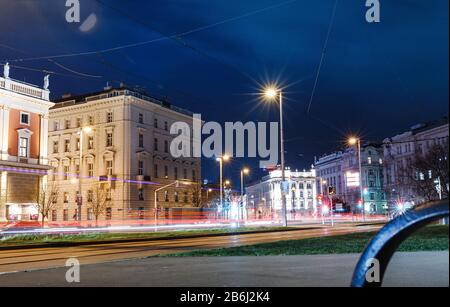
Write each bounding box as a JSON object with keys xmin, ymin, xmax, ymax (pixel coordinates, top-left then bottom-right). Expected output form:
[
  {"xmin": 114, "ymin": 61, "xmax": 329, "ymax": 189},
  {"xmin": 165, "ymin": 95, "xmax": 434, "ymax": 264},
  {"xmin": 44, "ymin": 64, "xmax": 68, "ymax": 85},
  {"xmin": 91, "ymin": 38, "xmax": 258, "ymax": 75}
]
[{"xmin": 0, "ymin": 252, "xmax": 449, "ymax": 287}]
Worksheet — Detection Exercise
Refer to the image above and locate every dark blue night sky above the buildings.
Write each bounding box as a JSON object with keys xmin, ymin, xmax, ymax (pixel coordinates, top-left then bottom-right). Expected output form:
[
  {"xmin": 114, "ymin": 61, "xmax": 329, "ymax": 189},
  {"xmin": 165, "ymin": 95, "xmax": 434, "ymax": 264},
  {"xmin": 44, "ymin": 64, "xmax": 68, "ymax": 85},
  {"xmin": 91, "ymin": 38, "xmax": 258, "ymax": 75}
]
[{"xmin": 0, "ymin": 0, "xmax": 449, "ymax": 183}]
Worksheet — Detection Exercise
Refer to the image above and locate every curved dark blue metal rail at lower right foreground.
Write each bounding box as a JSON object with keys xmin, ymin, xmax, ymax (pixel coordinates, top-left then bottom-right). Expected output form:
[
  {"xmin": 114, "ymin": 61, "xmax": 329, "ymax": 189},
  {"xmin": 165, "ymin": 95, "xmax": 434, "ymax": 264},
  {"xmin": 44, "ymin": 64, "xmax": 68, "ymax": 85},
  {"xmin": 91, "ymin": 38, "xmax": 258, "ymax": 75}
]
[{"xmin": 351, "ymin": 200, "xmax": 449, "ymax": 287}]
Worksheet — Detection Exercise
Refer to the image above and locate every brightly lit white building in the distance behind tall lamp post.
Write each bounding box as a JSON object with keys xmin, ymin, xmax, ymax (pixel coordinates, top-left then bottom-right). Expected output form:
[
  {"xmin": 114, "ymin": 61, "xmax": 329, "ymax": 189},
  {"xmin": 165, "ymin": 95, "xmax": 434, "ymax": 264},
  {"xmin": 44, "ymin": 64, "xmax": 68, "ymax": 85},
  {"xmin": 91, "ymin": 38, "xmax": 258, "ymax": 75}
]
[{"xmin": 246, "ymin": 169, "xmax": 317, "ymax": 217}]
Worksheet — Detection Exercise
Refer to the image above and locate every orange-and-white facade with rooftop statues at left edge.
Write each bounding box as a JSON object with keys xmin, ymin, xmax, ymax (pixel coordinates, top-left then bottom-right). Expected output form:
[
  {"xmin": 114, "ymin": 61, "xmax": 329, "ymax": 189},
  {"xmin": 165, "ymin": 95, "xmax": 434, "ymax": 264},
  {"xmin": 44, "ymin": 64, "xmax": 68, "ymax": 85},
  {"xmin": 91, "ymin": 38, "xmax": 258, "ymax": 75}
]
[{"xmin": 0, "ymin": 64, "xmax": 53, "ymax": 221}]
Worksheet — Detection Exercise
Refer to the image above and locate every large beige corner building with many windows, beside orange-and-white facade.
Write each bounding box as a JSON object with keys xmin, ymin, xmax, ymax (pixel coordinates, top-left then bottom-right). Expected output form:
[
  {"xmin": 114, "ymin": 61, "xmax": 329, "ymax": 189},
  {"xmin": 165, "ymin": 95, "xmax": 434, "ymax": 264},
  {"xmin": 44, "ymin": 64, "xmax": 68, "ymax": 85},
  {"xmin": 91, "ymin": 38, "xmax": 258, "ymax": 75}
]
[{"xmin": 48, "ymin": 87, "xmax": 201, "ymax": 221}]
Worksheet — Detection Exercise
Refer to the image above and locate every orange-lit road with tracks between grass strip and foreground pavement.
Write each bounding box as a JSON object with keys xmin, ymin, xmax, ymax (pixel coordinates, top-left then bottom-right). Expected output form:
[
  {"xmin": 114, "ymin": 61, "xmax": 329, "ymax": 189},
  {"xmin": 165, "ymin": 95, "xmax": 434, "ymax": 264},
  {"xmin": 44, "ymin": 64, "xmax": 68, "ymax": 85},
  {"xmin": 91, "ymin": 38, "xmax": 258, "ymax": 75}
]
[{"xmin": 0, "ymin": 225, "xmax": 380, "ymax": 274}]
